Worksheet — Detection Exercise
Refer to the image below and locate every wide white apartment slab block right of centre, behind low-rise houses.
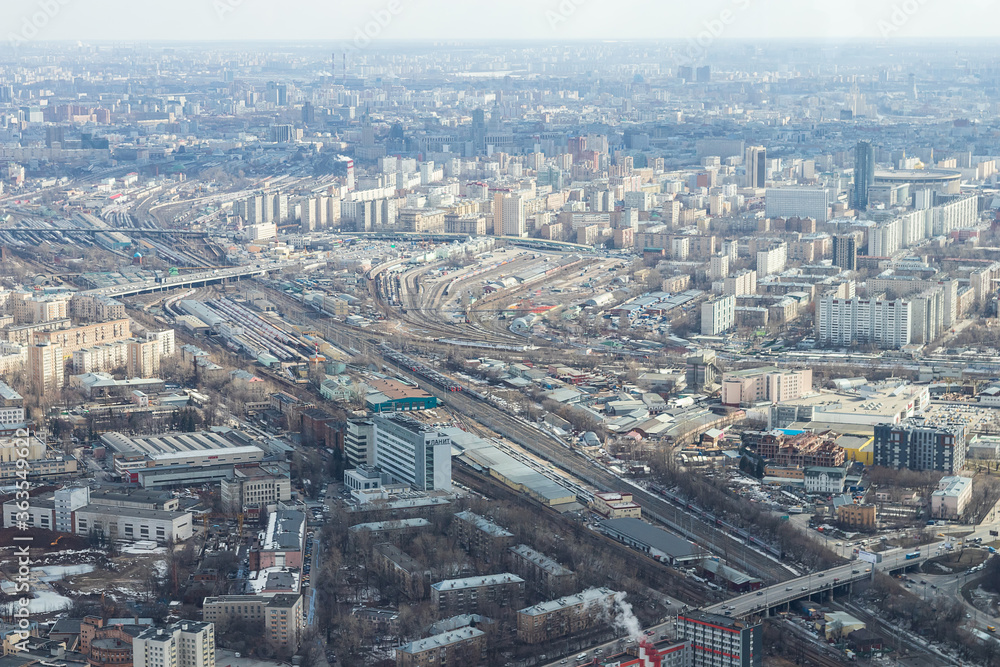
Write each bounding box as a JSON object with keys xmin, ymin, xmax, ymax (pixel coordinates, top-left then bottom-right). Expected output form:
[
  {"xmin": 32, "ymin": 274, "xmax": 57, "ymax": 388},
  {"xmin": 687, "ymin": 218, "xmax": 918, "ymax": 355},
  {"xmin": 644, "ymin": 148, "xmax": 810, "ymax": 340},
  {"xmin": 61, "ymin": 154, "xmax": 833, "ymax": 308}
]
[{"xmin": 816, "ymin": 296, "xmax": 912, "ymax": 350}]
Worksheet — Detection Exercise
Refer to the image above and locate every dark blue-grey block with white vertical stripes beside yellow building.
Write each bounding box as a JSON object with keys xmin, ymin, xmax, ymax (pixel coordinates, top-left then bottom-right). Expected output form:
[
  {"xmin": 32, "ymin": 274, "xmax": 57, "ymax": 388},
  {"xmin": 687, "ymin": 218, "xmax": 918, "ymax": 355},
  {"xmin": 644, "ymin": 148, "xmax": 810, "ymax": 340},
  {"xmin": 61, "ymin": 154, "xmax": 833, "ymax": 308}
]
[{"xmin": 874, "ymin": 417, "xmax": 966, "ymax": 475}]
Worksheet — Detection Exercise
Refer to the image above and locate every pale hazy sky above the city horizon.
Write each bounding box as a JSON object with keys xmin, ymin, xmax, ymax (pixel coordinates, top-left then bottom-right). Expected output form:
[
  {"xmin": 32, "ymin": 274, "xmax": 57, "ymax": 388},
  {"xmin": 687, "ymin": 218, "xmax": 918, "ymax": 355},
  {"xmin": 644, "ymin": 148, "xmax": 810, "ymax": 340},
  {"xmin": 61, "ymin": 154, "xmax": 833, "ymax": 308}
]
[{"xmin": 0, "ymin": 0, "xmax": 1000, "ymax": 41}]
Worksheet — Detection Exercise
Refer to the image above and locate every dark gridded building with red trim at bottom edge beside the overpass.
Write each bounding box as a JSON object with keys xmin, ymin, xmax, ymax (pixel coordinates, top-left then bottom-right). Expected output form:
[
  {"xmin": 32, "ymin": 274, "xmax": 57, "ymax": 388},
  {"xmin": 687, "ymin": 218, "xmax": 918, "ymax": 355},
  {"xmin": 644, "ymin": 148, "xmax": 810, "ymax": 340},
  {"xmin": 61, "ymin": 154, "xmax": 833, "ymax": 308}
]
[{"xmin": 675, "ymin": 611, "xmax": 764, "ymax": 667}]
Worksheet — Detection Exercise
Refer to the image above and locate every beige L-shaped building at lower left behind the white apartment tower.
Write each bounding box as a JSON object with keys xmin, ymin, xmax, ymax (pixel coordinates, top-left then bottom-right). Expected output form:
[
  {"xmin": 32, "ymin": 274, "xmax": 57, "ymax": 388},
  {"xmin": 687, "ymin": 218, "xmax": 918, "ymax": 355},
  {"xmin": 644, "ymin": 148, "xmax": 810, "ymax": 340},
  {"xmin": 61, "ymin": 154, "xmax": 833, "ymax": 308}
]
[{"xmin": 199, "ymin": 593, "xmax": 305, "ymax": 652}]
